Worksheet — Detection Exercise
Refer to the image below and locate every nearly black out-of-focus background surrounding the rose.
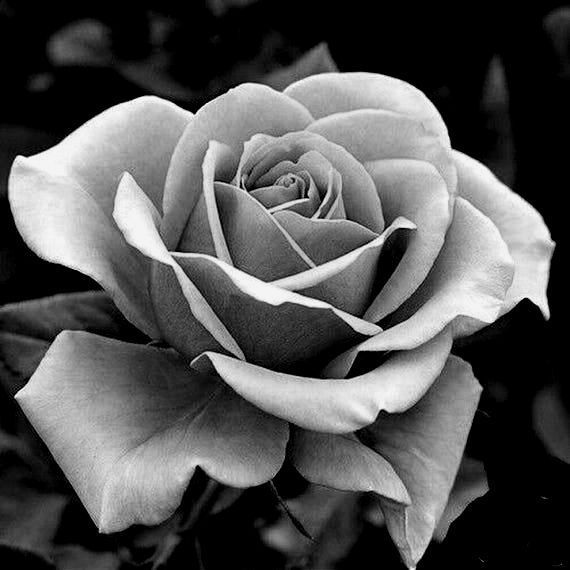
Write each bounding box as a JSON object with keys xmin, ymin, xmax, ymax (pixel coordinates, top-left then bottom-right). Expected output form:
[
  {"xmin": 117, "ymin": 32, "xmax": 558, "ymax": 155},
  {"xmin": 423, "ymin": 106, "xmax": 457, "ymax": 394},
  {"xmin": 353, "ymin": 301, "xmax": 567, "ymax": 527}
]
[{"xmin": 0, "ymin": 0, "xmax": 570, "ymax": 569}]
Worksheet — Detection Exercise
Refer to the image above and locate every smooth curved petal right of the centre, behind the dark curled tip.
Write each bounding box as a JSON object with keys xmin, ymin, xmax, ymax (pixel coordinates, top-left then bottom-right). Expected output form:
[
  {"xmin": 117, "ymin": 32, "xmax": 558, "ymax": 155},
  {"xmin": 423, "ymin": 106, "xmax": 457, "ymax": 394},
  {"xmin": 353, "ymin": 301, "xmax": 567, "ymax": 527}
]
[{"xmin": 365, "ymin": 159, "xmax": 450, "ymax": 322}]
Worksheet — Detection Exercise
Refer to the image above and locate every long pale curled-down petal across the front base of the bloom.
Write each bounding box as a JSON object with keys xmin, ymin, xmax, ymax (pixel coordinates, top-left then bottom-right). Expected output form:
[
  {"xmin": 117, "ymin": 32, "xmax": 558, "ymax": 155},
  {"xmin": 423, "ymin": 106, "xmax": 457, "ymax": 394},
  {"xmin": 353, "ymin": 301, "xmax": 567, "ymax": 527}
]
[{"xmin": 191, "ymin": 333, "xmax": 451, "ymax": 434}]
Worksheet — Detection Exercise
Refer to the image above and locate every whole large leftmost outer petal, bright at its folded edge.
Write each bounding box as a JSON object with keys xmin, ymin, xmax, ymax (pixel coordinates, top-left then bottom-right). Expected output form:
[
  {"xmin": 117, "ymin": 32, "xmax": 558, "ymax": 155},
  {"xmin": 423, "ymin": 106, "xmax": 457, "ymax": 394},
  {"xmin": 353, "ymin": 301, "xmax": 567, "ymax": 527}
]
[{"xmin": 9, "ymin": 97, "xmax": 192, "ymax": 337}]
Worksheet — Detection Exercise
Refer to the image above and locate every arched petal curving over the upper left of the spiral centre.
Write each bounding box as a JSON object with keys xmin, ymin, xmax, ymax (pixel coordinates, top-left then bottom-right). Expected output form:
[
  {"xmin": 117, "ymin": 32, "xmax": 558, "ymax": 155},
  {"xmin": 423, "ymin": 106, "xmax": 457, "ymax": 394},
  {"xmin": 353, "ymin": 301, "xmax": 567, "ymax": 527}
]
[{"xmin": 161, "ymin": 84, "xmax": 312, "ymax": 248}]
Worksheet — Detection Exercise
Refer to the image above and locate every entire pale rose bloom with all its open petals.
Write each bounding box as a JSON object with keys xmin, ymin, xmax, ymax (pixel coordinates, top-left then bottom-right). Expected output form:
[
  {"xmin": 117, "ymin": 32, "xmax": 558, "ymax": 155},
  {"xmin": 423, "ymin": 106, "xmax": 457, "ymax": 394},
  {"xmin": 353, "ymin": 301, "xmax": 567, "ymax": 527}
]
[{"xmin": 9, "ymin": 73, "xmax": 553, "ymax": 566}]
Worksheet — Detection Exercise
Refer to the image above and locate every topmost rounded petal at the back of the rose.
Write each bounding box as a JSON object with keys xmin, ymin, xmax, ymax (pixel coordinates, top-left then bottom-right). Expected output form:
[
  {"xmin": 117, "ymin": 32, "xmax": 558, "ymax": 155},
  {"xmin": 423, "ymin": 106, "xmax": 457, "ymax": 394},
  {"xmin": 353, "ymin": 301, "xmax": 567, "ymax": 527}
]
[{"xmin": 285, "ymin": 73, "xmax": 449, "ymax": 146}]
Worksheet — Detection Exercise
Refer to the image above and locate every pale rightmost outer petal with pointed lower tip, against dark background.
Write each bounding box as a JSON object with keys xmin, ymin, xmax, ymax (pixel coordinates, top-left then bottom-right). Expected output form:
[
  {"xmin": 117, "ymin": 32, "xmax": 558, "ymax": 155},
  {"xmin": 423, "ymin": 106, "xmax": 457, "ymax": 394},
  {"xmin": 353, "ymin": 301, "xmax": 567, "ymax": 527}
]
[{"xmin": 453, "ymin": 151, "xmax": 554, "ymax": 318}]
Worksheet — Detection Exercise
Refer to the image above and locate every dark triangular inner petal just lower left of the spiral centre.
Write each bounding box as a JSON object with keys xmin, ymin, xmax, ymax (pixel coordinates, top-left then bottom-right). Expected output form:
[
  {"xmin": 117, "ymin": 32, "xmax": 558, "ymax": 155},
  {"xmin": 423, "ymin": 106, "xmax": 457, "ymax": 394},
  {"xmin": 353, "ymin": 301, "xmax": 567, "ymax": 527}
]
[{"xmin": 215, "ymin": 182, "xmax": 315, "ymax": 281}]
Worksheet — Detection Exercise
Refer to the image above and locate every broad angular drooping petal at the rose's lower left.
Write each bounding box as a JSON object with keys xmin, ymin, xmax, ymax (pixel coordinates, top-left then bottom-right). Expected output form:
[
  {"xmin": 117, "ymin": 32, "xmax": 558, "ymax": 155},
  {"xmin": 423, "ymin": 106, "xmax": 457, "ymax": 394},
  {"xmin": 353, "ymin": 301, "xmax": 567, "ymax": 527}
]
[{"xmin": 16, "ymin": 332, "xmax": 288, "ymax": 532}]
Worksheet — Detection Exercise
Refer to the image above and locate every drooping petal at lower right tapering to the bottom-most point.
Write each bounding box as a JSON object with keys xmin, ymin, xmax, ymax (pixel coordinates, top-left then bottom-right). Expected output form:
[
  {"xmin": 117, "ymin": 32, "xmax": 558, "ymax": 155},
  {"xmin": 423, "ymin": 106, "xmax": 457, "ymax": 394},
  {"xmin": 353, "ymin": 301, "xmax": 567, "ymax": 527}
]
[{"xmin": 360, "ymin": 356, "xmax": 481, "ymax": 568}]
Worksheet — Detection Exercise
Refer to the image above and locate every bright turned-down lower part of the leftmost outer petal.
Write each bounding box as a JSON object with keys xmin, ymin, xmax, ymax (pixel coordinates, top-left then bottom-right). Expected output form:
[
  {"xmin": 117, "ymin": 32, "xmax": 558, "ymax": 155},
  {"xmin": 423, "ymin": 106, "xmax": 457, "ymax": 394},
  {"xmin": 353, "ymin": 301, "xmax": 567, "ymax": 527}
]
[{"xmin": 9, "ymin": 157, "xmax": 160, "ymax": 338}]
